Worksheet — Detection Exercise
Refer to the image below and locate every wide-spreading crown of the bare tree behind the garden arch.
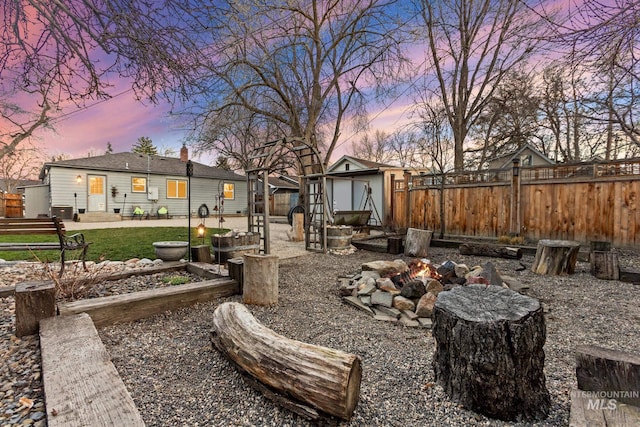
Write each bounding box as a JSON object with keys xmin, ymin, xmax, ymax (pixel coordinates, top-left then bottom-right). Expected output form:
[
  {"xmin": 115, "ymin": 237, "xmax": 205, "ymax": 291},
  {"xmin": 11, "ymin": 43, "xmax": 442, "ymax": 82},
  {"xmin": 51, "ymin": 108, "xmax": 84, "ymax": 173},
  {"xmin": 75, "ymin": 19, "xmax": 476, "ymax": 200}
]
[{"xmin": 191, "ymin": 0, "xmax": 404, "ymax": 171}]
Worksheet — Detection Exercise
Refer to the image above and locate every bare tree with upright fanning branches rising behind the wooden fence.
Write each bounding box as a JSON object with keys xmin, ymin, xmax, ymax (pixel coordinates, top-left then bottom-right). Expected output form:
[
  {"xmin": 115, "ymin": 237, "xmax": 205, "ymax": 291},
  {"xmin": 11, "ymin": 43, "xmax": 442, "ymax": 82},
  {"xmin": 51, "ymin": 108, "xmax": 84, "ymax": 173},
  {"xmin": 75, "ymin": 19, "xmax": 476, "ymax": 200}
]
[{"xmin": 418, "ymin": 0, "xmax": 546, "ymax": 170}]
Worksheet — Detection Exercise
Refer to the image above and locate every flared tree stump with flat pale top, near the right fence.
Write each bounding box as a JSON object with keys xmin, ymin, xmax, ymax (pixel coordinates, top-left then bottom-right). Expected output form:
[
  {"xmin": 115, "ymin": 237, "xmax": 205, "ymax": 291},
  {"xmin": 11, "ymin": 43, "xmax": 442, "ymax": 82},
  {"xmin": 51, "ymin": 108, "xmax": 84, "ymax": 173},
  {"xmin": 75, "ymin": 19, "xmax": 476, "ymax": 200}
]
[{"xmin": 531, "ymin": 240, "xmax": 580, "ymax": 276}]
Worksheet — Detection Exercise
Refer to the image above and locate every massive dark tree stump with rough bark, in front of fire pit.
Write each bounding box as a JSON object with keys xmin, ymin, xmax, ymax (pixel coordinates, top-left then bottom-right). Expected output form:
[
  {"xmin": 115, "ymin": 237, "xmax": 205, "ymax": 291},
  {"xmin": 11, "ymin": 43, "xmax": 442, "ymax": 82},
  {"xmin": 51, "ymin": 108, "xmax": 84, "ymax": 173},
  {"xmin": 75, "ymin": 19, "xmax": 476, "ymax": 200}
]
[{"xmin": 432, "ymin": 285, "xmax": 550, "ymax": 420}]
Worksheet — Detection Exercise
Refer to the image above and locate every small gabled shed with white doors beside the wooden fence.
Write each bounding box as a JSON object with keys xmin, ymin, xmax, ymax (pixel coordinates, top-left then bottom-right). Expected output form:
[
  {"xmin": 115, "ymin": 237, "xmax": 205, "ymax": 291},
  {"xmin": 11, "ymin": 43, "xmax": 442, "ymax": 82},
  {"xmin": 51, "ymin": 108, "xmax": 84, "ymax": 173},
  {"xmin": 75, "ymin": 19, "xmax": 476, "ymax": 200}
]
[{"xmin": 327, "ymin": 155, "xmax": 412, "ymax": 226}]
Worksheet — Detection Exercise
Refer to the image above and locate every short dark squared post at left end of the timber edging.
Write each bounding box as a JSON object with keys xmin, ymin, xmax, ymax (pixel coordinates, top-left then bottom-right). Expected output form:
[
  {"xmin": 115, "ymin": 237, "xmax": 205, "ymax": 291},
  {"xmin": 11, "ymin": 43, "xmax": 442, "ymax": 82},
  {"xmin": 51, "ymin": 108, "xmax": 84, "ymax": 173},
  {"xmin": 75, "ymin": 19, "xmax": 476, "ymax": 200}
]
[{"xmin": 15, "ymin": 281, "xmax": 56, "ymax": 337}]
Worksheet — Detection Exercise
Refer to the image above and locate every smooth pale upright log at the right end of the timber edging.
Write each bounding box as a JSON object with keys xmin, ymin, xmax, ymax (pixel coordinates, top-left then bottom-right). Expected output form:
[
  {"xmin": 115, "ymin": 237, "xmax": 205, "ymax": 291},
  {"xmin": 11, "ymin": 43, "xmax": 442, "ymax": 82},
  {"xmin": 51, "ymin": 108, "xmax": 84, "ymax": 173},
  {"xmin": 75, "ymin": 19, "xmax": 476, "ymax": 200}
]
[{"xmin": 242, "ymin": 254, "xmax": 278, "ymax": 305}]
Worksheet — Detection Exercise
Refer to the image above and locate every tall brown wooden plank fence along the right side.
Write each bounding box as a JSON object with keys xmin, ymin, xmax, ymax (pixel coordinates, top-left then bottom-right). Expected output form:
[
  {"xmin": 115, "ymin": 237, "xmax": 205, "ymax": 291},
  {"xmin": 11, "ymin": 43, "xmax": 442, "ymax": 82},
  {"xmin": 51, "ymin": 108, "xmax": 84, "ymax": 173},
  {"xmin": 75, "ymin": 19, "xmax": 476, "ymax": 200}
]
[{"xmin": 391, "ymin": 160, "xmax": 640, "ymax": 246}]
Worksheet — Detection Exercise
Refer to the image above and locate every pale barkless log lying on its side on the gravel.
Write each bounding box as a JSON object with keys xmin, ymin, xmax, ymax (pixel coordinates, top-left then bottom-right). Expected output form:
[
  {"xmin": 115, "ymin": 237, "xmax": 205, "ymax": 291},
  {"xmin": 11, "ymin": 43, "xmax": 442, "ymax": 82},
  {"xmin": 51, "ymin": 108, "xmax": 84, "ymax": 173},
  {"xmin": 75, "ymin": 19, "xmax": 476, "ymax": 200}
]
[{"xmin": 213, "ymin": 302, "xmax": 362, "ymax": 420}]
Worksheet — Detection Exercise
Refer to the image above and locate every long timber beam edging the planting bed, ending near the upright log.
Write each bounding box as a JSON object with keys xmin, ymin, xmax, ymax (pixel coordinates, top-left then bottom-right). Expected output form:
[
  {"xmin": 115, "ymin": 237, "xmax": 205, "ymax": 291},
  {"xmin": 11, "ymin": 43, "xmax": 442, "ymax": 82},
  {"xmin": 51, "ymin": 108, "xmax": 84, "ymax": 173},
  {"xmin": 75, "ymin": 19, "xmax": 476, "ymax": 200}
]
[{"xmin": 58, "ymin": 279, "xmax": 239, "ymax": 327}]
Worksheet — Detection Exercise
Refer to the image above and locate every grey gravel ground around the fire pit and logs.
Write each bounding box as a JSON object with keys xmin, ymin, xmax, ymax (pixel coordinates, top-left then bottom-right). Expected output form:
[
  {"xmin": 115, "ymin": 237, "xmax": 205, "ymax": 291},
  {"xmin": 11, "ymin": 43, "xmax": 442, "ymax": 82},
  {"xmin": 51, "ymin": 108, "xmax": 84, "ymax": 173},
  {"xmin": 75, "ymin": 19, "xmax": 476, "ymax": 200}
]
[{"xmin": 0, "ymin": 248, "xmax": 640, "ymax": 426}]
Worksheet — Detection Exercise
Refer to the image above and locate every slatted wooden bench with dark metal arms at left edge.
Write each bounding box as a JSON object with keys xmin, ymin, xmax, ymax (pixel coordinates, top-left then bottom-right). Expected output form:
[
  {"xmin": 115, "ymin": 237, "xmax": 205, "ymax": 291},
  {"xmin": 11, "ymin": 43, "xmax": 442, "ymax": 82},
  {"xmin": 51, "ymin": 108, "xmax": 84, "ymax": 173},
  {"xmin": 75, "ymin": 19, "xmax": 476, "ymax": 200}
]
[{"xmin": 0, "ymin": 216, "xmax": 91, "ymax": 277}]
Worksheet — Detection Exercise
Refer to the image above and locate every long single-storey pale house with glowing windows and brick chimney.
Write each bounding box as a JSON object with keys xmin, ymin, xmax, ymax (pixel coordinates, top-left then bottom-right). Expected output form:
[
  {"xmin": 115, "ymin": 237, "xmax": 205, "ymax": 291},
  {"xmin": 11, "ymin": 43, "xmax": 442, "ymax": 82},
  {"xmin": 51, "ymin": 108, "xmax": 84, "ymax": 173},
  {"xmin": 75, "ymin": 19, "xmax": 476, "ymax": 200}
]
[{"xmin": 25, "ymin": 147, "xmax": 247, "ymax": 220}]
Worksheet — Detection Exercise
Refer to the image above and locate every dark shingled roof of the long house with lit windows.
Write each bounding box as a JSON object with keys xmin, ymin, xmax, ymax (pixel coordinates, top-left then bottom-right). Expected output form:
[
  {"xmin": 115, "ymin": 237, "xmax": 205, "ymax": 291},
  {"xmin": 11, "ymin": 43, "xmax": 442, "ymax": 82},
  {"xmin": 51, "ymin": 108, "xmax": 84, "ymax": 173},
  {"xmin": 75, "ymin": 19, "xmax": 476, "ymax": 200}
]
[{"xmin": 40, "ymin": 152, "xmax": 245, "ymax": 181}]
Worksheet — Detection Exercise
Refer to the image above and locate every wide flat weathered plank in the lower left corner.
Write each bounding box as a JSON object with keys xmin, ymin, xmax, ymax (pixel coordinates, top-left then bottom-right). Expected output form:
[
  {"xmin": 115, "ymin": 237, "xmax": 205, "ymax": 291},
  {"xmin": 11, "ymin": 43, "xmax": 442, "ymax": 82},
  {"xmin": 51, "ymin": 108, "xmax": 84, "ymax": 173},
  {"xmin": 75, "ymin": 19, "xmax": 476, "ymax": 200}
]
[{"xmin": 40, "ymin": 313, "xmax": 144, "ymax": 427}]
